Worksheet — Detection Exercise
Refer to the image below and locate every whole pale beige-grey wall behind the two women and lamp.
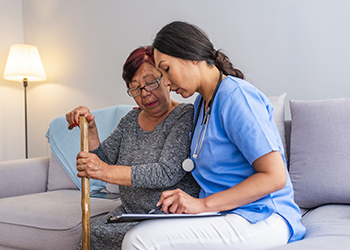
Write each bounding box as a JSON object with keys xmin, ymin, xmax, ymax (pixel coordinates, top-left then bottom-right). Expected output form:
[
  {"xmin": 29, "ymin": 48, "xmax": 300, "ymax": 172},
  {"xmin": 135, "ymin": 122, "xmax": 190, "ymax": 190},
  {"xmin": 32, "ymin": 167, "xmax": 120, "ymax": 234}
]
[{"xmin": 0, "ymin": 0, "xmax": 350, "ymax": 160}]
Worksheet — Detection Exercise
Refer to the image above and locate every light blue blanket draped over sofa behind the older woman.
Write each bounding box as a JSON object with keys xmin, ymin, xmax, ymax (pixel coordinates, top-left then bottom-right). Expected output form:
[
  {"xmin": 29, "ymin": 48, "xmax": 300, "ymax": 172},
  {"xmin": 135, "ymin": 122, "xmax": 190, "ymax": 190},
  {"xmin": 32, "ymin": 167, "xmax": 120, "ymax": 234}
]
[{"xmin": 46, "ymin": 105, "xmax": 133, "ymax": 193}]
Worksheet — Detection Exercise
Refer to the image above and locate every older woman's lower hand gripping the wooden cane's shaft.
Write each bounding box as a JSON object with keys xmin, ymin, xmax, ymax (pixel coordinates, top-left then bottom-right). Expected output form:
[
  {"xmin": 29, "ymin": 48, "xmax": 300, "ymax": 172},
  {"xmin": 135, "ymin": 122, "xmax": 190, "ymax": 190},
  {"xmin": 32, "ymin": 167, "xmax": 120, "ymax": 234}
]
[{"xmin": 76, "ymin": 151, "xmax": 109, "ymax": 181}]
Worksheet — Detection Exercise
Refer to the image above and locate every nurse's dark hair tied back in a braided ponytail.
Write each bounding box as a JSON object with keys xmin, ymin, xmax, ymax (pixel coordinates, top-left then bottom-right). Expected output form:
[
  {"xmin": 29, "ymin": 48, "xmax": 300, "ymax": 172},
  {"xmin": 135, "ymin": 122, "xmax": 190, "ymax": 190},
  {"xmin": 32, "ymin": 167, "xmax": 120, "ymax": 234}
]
[{"xmin": 152, "ymin": 21, "xmax": 244, "ymax": 79}]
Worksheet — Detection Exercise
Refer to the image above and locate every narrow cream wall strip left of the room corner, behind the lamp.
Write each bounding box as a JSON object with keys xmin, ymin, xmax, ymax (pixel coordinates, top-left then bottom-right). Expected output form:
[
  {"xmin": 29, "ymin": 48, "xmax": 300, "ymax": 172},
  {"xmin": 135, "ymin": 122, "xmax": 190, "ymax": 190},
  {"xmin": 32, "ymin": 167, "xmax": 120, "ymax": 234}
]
[{"xmin": 0, "ymin": 0, "xmax": 25, "ymax": 161}]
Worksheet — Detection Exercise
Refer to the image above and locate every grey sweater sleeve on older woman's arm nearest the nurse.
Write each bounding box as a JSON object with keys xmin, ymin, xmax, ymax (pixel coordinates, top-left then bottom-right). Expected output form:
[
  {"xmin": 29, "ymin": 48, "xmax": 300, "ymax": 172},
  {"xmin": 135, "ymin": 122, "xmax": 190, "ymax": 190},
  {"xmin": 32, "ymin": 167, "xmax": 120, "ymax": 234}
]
[{"xmin": 132, "ymin": 104, "xmax": 193, "ymax": 188}]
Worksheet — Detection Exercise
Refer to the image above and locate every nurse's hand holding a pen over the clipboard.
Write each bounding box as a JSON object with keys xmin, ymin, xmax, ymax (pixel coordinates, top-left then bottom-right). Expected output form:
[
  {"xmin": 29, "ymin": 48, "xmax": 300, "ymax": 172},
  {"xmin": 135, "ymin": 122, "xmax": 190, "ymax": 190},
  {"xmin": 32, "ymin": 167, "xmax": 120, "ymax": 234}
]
[{"xmin": 157, "ymin": 189, "xmax": 206, "ymax": 214}]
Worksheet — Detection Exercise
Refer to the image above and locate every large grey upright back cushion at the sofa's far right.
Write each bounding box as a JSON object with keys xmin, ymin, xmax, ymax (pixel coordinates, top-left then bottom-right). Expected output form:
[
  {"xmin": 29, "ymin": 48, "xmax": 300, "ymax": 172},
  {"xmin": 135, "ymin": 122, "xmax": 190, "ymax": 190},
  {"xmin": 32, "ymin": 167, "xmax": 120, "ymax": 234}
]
[{"xmin": 290, "ymin": 98, "xmax": 350, "ymax": 208}]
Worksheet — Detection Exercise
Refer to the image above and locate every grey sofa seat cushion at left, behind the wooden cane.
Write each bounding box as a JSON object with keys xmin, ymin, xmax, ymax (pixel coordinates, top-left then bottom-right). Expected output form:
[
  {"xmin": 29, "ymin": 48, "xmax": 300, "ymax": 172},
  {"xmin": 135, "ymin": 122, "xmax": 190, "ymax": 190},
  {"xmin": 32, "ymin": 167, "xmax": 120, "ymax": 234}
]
[{"xmin": 0, "ymin": 190, "xmax": 121, "ymax": 249}]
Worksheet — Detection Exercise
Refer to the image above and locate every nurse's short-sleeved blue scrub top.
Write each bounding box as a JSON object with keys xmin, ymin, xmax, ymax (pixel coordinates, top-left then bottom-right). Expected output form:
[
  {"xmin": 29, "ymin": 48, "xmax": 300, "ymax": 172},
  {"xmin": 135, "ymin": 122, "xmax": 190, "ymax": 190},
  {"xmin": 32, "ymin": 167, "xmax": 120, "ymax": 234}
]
[{"xmin": 191, "ymin": 76, "xmax": 305, "ymax": 242}]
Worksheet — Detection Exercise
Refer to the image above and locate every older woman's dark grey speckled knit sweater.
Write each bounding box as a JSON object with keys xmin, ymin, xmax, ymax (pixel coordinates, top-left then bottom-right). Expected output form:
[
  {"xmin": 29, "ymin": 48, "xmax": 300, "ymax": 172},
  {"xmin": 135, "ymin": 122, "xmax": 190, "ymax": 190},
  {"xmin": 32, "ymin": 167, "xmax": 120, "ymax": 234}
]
[{"xmin": 92, "ymin": 103, "xmax": 199, "ymax": 213}]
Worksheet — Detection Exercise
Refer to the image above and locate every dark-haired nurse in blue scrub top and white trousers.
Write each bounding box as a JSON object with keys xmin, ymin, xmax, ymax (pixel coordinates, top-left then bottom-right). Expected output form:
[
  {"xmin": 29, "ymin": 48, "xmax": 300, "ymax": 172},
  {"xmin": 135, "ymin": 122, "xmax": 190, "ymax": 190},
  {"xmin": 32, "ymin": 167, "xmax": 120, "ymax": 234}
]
[{"xmin": 123, "ymin": 21, "xmax": 305, "ymax": 250}]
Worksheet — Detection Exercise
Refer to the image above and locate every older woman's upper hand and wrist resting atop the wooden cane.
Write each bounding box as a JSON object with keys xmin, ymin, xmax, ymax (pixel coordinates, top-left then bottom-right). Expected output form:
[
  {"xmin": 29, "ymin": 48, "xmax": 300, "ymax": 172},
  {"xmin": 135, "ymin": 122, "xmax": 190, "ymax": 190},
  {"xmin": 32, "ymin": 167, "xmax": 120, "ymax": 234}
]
[{"xmin": 66, "ymin": 106, "xmax": 100, "ymax": 150}]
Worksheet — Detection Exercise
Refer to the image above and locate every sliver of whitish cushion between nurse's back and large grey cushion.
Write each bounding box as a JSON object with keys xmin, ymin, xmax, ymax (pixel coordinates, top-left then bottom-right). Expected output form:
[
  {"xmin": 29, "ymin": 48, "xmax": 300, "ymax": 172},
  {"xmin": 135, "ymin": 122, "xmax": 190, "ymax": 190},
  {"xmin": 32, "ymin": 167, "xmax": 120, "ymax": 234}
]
[{"xmin": 269, "ymin": 93, "xmax": 287, "ymax": 159}]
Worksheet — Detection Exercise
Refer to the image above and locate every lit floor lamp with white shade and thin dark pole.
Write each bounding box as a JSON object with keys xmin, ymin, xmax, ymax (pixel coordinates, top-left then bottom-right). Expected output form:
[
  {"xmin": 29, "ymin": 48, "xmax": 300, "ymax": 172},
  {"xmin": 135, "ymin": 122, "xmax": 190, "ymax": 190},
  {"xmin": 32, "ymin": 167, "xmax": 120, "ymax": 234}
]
[{"xmin": 4, "ymin": 44, "xmax": 46, "ymax": 158}]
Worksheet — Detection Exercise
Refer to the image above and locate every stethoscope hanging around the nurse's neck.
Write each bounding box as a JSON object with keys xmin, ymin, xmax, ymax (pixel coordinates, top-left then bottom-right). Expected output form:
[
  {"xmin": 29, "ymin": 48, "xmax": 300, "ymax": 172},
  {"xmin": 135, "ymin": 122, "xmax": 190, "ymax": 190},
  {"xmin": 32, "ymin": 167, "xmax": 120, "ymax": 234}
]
[{"xmin": 182, "ymin": 71, "xmax": 222, "ymax": 172}]
